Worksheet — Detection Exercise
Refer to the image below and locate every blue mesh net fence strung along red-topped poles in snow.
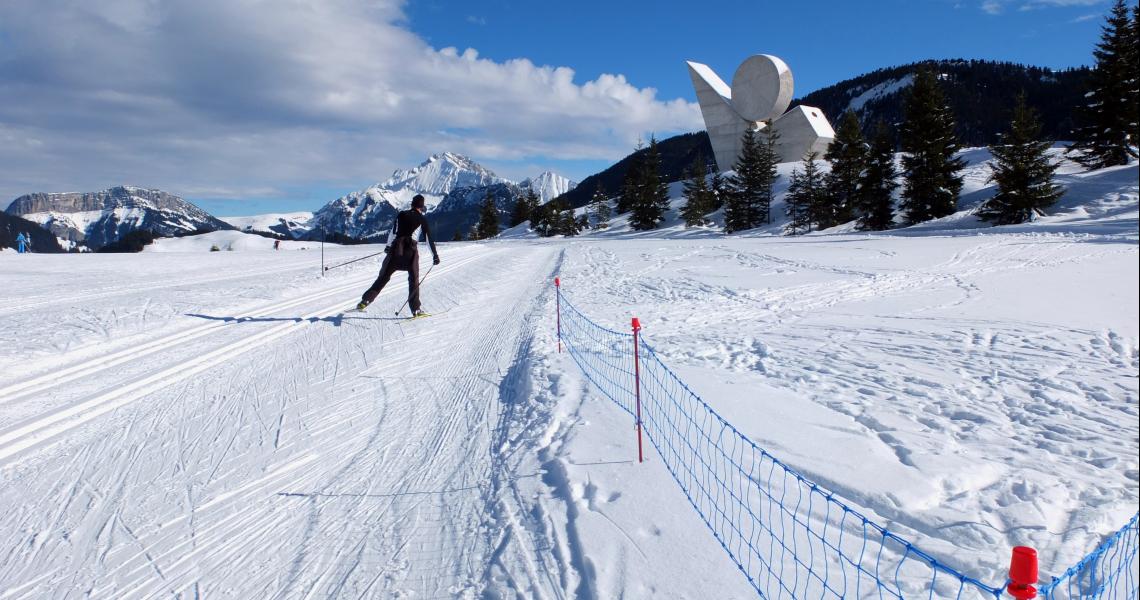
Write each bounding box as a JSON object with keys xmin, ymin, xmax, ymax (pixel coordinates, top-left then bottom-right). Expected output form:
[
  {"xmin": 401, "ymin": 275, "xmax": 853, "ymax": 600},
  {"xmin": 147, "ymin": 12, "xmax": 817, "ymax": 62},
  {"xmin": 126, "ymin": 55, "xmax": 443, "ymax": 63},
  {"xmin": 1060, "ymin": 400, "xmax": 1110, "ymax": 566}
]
[{"xmin": 555, "ymin": 279, "xmax": 1140, "ymax": 599}]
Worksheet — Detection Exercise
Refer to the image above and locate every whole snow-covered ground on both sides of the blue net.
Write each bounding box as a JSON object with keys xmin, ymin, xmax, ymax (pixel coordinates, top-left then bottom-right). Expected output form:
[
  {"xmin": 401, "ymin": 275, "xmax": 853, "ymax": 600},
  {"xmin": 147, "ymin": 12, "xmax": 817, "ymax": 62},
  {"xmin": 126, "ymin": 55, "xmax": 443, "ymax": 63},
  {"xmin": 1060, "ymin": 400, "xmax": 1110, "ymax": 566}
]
[{"xmin": 0, "ymin": 171, "xmax": 1140, "ymax": 598}]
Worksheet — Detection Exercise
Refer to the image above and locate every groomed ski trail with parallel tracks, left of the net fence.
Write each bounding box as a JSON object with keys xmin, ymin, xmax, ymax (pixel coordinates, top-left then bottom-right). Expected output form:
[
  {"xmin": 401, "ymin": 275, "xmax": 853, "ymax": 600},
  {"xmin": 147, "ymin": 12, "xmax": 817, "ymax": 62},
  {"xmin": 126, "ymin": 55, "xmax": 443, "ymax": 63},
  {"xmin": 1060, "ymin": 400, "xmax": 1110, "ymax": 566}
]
[{"xmin": 0, "ymin": 244, "xmax": 578, "ymax": 599}]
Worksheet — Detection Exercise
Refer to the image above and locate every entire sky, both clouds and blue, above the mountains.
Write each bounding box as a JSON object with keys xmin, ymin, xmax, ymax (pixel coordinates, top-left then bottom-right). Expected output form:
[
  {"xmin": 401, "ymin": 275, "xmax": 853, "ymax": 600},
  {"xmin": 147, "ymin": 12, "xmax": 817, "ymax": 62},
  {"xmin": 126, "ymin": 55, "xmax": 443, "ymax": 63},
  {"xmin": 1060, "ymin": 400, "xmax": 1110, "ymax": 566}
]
[{"xmin": 0, "ymin": 0, "xmax": 1110, "ymax": 216}]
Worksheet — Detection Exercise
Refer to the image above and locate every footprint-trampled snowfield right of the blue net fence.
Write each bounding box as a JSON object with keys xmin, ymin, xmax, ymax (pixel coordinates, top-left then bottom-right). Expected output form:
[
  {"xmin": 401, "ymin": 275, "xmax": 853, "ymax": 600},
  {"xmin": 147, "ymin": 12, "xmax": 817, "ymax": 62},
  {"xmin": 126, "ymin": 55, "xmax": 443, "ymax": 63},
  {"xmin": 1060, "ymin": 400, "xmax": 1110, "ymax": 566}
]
[{"xmin": 563, "ymin": 235, "xmax": 1140, "ymax": 577}]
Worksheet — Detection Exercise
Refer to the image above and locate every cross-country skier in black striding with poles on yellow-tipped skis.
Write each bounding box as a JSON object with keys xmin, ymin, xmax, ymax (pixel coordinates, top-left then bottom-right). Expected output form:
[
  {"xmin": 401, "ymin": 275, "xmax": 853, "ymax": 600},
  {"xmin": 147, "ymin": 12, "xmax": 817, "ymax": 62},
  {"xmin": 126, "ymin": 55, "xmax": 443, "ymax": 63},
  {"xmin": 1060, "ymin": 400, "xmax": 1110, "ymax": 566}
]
[{"xmin": 357, "ymin": 194, "xmax": 439, "ymax": 317}]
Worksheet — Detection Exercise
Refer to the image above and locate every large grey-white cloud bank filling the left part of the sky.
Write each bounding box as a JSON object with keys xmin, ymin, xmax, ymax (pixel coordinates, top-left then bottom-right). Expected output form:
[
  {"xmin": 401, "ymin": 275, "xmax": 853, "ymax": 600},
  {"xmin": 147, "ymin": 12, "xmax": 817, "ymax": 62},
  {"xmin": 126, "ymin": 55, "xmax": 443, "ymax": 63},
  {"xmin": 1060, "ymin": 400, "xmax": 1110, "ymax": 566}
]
[{"xmin": 0, "ymin": 0, "xmax": 702, "ymax": 204}]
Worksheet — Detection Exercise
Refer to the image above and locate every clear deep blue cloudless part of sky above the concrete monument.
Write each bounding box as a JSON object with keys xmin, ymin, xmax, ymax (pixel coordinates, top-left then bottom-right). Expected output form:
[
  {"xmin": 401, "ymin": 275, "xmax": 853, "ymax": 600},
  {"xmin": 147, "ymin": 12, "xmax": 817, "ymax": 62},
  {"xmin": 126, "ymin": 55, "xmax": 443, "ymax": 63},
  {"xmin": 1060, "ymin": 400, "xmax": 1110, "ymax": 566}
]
[{"xmin": 407, "ymin": 0, "xmax": 1110, "ymax": 106}]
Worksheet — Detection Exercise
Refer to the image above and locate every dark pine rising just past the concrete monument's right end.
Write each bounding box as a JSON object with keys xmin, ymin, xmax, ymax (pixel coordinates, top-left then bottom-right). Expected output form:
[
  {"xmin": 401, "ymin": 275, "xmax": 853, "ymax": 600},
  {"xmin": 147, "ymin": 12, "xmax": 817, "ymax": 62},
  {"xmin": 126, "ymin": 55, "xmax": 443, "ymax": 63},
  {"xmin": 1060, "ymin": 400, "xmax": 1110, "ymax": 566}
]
[{"xmin": 817, "ymin": 108, "xmax": 868, "ymax": 229}]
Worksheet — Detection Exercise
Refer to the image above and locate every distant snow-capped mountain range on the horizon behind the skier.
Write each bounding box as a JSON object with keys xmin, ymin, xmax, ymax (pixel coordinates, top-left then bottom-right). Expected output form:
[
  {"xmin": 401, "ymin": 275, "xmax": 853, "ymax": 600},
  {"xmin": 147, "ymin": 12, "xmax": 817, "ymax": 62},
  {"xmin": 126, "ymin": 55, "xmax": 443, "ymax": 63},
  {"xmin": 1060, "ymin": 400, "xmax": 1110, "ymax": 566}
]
[{"xmin": 6, "ymin": 153, "xmax": 576, "ymax": 250}]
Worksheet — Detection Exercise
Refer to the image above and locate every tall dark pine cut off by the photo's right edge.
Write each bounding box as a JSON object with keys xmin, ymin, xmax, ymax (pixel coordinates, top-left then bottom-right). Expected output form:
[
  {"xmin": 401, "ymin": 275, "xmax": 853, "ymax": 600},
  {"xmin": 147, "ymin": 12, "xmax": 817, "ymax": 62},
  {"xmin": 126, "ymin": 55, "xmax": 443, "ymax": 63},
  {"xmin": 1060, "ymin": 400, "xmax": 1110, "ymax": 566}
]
[{"xmin": 1068, "ymin": 0, "xmax": 1140, "ymax": 169}]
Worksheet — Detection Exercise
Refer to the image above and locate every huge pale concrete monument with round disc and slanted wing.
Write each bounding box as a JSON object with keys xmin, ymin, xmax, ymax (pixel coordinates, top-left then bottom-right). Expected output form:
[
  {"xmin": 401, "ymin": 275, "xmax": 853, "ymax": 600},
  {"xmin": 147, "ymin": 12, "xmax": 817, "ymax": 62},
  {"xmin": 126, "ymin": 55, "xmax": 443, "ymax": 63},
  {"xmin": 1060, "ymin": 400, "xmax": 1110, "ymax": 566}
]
[{"xmin": 686, "ymin": 54, "xmax": 836, "ymax": 171}]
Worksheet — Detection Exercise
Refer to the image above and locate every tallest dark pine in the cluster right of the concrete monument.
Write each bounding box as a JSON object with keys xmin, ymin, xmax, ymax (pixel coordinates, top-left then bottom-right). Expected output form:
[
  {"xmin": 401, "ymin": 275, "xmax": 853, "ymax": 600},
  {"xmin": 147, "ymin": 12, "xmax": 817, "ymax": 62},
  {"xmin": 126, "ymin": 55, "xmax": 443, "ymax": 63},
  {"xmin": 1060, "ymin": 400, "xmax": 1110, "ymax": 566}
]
[{"xmin": 901, "ymin": 67, "xmax": 966, "ymax": 225}]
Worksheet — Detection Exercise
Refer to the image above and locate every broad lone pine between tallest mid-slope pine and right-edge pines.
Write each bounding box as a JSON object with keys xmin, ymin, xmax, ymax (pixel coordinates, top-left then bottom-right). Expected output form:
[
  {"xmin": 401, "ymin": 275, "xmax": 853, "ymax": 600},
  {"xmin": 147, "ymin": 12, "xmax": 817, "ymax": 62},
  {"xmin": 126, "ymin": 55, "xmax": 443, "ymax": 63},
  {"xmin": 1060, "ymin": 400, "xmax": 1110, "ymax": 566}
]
[{"xmin": 978, "ymin": 94, "xmax": 1065, "ymax": 225}]
